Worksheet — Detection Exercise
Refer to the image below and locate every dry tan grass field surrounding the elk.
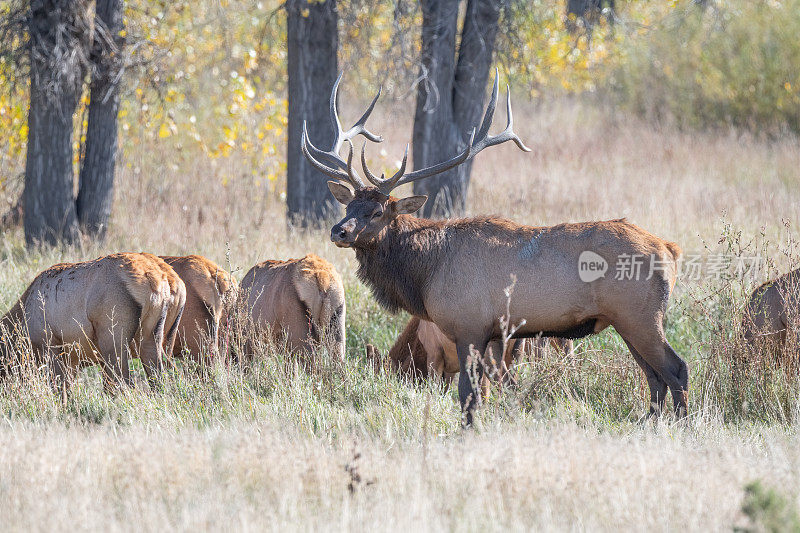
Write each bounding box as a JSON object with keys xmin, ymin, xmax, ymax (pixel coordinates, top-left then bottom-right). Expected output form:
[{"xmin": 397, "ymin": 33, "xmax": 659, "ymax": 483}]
[{"xmin": 0, "ymin": 99, "xmax": 800, "ymax": 531}]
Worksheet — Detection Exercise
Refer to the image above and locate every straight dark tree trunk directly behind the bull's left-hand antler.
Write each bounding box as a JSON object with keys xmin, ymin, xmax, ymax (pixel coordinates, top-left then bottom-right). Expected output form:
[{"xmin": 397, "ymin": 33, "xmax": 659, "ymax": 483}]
[{"xmin": 286, "ymin": 0, "xmax": 339, "ymax": 226}]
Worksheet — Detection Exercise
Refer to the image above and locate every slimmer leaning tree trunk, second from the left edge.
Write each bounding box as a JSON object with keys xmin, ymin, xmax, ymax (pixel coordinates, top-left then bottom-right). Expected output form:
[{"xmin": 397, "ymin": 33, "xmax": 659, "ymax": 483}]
[{"xmin": 77, "ymin": 0, "xmax": 124, "ymax": 239}]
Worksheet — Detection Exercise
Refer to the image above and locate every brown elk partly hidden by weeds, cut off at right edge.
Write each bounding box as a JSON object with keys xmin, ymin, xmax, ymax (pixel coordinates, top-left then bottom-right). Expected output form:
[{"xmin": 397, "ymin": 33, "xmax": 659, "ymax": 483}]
[{"xmin": 742, "ymin": 269, "xmax": 800, "ymax": 358}]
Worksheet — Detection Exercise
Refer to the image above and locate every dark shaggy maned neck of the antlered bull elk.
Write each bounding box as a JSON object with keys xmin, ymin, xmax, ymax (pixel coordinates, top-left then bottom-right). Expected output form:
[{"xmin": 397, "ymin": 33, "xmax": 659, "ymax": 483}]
[{"xmin": 356, "ymin": 215, "xmax": 446, "ymax": 319}]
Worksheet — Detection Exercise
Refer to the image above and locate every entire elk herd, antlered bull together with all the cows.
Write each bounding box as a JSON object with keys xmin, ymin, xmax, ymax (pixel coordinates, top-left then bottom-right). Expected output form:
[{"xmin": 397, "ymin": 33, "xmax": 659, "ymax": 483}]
[{"xmin": 0, "ymin": 71, "xmax": 800, "ymax": 425}]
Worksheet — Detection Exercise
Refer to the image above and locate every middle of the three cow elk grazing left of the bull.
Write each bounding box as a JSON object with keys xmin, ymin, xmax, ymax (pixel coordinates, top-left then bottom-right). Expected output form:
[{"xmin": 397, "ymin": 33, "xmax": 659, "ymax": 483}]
[{"xmin": 161, "ymin": 255, "xmax": 237, "ymax": 364}]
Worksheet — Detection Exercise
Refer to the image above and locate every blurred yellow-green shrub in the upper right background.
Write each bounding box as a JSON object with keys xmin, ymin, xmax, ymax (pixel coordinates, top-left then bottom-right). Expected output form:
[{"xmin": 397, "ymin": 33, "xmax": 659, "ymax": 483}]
[{"xmin": 609, "ymin": 0, "xmax": 800, "ymax": 134}]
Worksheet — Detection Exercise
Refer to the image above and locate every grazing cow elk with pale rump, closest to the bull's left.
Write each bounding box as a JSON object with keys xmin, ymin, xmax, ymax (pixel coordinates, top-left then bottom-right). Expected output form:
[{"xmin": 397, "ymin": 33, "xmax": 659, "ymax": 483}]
[{"xmin": 240, "ymin": 254, "xmax": 345, "ymax": 359}]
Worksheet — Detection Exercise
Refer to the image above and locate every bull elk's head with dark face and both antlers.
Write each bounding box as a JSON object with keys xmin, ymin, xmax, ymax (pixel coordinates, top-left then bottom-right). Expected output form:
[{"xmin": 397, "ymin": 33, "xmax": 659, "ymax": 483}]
[{"xmin": 302, "ymin": 70, "xmax": 530, "ymax": 248}]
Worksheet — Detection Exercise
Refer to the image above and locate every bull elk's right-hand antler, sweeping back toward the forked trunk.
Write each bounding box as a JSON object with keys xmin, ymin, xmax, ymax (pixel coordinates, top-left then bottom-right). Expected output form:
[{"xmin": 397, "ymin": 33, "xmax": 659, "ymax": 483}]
[{"xmin": 361, "ymin": 69, "xmax": 531, "ymax": 194}]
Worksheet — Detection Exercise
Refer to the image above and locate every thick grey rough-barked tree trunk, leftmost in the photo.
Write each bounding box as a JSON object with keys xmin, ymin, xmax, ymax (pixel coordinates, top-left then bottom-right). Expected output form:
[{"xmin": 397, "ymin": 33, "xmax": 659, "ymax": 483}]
[{"xmin": 23, "ymin": 0, "xmax": 85, "ymax": 246}]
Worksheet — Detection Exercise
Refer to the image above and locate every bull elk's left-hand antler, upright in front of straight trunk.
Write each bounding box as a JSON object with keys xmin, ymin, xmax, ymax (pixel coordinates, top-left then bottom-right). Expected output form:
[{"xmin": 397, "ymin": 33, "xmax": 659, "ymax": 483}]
[{"xmin": 302, "ymin": 72, "xmax": 383, "ymax": 189}]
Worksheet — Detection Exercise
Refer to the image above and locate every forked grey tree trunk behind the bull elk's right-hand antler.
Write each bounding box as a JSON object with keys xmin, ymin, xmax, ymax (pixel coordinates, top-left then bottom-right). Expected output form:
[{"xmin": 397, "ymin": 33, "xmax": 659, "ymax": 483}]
[{"xmin": 413, "ymin": 0, "xmax": 504, "ymax": 217}]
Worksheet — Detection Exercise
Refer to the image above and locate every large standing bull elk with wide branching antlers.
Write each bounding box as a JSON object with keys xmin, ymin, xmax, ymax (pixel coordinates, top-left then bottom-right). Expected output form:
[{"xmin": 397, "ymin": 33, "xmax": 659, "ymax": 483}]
[{"xmin": 302, "ymin": 69, "xmax": 689, "ymax": 425}]
